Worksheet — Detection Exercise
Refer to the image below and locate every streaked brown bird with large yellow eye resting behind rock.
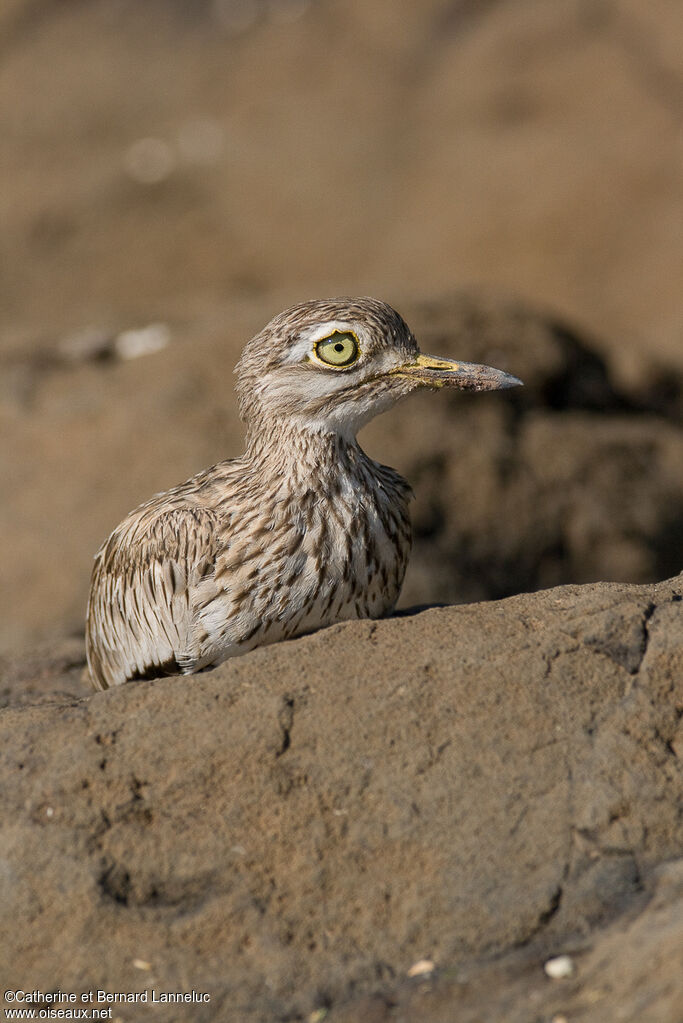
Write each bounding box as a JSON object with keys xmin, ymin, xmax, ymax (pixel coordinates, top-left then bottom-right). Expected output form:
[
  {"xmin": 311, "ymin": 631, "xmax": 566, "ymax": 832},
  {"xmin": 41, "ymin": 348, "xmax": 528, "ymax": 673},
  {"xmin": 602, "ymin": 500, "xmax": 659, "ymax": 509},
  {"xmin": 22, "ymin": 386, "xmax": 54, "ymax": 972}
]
[{"xmin": 86, "ymin": 298, "xmax": 521, "ymax": 690}]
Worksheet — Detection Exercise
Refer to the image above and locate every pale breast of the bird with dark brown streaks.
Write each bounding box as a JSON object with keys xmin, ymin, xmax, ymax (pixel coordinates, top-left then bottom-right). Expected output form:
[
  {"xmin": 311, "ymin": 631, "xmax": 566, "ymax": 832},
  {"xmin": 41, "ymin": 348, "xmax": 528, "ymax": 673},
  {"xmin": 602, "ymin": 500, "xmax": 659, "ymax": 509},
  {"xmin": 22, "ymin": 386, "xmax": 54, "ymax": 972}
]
[{"xmin": 194, "ymin": 458, "xmax": 410, "ymax": 659}]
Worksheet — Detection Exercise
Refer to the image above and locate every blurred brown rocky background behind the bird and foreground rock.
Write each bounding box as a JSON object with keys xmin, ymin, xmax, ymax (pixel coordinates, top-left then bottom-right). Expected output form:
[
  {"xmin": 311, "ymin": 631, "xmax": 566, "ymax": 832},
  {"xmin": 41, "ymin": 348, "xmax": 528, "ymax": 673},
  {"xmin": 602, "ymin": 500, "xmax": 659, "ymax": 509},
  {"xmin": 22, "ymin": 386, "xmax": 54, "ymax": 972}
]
[{"xmin": 0, "ymin": 0, "xmax": 683, "ymax": 649}]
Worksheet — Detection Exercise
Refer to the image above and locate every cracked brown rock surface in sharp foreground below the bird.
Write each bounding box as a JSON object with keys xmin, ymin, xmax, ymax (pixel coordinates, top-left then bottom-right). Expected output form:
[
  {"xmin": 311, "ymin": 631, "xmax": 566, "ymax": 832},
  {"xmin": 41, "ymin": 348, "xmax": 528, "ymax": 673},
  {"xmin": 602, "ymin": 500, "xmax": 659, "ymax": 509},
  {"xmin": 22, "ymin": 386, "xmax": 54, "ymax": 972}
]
[{"xmin": 0, "ymin": 576, "xmax": 683, "ymax": 1023}]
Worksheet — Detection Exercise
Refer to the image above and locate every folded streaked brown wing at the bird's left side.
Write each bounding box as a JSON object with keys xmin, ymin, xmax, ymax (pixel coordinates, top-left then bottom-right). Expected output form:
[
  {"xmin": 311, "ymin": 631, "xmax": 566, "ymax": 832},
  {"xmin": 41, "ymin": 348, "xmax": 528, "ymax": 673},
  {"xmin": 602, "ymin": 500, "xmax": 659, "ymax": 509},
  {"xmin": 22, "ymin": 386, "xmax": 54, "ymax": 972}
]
[{"xmin": 86, "ymin": 507, "xmax": 225, "ymax": 690}]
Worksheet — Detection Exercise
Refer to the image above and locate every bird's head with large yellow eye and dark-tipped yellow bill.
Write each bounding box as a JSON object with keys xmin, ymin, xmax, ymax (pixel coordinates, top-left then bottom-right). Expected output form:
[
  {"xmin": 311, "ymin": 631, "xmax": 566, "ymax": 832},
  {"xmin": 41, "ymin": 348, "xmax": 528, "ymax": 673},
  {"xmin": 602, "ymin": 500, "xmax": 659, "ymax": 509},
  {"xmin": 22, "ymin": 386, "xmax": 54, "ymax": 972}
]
[{"xmin": 235, "ymin": 298, "xmax": 521, "ymax": 438}]
